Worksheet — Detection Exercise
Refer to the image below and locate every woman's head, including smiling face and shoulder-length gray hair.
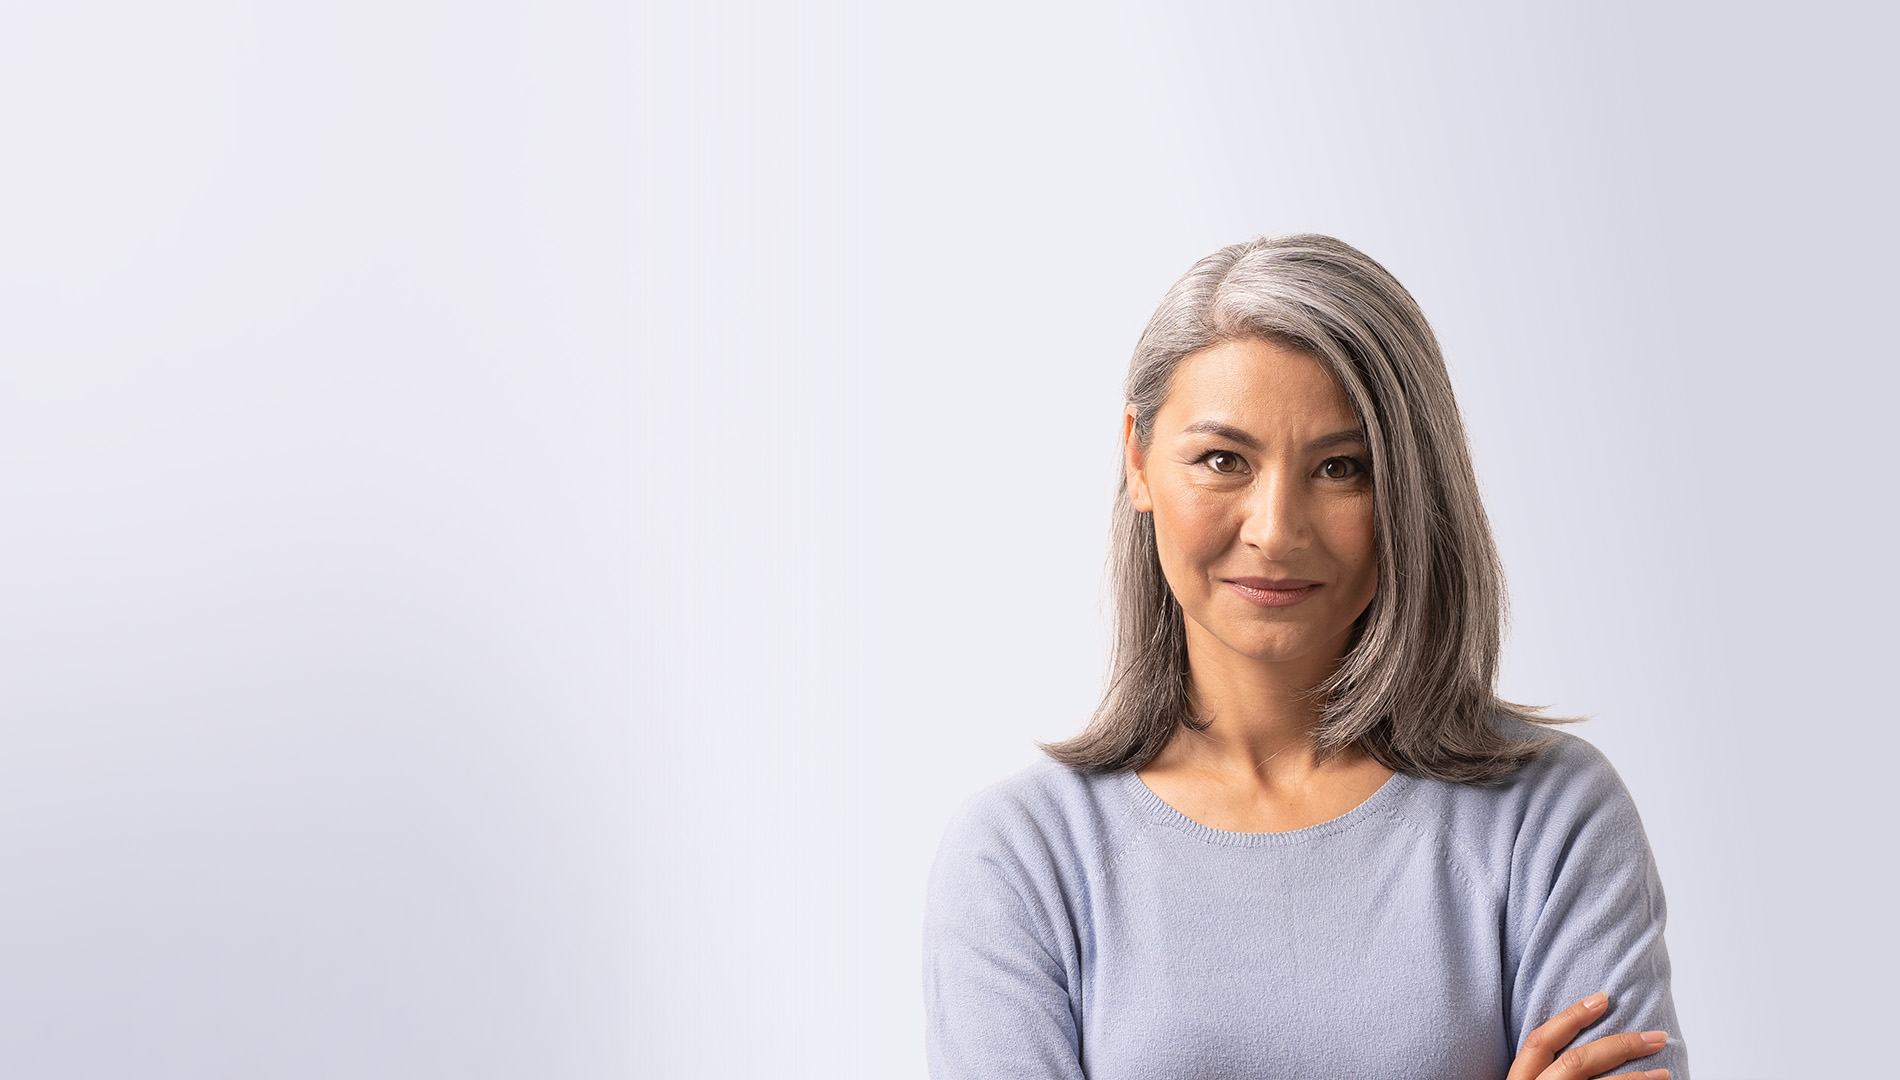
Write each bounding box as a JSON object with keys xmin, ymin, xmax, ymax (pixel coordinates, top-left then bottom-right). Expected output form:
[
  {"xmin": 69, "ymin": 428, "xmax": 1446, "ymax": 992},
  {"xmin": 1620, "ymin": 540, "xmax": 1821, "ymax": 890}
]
[{"xmin": 1045, "ymin": 236, "xmax": 1539, "ymax": 781}]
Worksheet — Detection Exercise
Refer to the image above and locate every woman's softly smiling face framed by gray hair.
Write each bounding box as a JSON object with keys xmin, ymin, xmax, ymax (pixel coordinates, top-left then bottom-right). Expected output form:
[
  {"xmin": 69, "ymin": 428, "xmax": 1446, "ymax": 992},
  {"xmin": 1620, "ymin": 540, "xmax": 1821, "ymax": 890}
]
[{"xmin": 1123, "ymin": 340, "xmax": 1378, "ymax": 681}]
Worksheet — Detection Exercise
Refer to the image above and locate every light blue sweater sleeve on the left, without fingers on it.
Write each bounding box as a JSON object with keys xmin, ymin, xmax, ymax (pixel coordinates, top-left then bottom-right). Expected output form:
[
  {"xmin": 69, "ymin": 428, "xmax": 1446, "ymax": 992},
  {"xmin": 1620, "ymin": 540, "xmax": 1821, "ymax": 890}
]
[{"xmin": 923, "ymin": 791, "xmax": 1083, "ymax": 1080}]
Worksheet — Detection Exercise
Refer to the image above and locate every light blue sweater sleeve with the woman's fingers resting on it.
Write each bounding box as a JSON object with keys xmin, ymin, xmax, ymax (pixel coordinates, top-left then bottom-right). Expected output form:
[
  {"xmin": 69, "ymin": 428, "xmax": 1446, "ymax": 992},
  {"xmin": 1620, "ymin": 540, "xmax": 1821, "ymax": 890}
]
[{"xmin": 1507, "ymin": 738, "xmax": 1689, "ymax": 1080}]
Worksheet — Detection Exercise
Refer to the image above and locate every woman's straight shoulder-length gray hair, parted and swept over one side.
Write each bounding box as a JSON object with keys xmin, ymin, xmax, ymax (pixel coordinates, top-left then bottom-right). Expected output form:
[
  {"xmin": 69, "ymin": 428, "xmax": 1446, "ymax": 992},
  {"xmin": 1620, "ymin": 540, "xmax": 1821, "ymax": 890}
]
[{"xmin": 1043, "ymin": 234, "xmax": 1566, "ymax": 783}]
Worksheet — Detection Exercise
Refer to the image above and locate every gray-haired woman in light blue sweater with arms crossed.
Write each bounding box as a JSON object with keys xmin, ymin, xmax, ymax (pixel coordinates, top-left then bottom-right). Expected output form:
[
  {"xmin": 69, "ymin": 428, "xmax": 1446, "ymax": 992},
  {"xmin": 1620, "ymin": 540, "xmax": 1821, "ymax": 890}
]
[{"xmin": 925, "ymin": 236, "xmax": 1687, "ymax": 1080}]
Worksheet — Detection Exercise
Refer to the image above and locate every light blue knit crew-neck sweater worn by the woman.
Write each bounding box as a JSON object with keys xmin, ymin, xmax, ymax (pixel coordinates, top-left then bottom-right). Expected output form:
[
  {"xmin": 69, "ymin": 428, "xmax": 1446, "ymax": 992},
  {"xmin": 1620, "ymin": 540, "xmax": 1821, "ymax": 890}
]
[{"xmin": 923, "ymin": 721, "xmax": 1689, "ymax": 1080}]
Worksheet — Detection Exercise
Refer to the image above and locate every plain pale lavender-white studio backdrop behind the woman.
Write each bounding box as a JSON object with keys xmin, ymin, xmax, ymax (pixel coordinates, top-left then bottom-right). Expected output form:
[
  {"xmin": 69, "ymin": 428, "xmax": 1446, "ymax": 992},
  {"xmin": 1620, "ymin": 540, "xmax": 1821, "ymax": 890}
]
[{"xmin": 0, "ymin": 0, "xmax": 1900, "ymax": 1080}]
